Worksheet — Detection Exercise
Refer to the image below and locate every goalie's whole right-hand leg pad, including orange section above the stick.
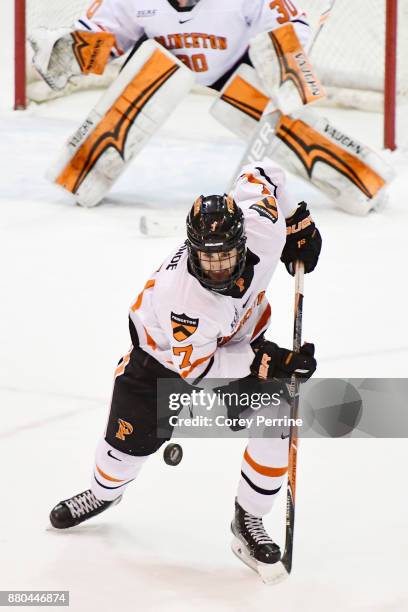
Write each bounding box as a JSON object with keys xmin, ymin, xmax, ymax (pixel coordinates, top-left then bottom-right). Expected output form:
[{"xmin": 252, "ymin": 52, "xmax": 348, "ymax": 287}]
[{"xmin": 211, "ymin": 65, "xmax": 394, "ymax": 215}]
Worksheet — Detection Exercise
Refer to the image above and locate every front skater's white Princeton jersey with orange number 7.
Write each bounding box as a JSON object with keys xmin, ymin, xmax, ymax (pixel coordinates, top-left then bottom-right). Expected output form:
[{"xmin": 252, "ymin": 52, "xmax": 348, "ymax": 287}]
[{"xmin": 130, "ymin": 160, "xmax": 294, "ymax": 384}]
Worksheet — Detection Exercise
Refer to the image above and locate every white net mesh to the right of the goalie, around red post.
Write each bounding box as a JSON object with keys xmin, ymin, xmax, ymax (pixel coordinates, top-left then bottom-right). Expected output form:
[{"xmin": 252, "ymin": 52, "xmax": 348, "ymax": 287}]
[{"xmin": 302, "ymin": 0, "xmax": 408, "ymax": 110}]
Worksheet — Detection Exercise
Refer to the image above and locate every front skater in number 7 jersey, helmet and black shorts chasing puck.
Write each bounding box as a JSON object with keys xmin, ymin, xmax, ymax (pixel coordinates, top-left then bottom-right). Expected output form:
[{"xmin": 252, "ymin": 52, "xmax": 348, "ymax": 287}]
[{"xmin": 50, "ymin": 160, "xmax": 321, "ymax": 564}]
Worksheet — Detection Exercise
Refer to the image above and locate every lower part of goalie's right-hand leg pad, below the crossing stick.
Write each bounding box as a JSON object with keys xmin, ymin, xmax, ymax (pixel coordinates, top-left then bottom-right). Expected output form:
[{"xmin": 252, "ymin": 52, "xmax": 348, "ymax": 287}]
[{"xmin": 268, "ymin": 109, "xmax": 394, "ymax": 215}]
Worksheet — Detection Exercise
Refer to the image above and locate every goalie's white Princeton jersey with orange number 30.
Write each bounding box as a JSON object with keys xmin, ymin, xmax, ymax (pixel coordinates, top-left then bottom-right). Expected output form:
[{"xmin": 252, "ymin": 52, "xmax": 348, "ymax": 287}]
[{"xmin": 75, "ymin": 0, "xmax": 310, "ymax": 85}]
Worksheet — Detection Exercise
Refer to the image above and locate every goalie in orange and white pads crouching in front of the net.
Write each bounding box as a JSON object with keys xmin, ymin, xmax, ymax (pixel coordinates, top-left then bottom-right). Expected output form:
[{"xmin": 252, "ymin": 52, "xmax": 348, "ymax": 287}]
[{"xmin": 30, "ymin": 0, "xmax": 392, "ymax": 214}]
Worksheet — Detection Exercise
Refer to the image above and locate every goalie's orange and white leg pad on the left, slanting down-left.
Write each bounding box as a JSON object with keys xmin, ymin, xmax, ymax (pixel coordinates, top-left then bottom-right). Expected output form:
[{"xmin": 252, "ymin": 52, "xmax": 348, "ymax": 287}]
[{"xmin": 47, "ymin": 40, "xmax": 194, "ymax": 207}]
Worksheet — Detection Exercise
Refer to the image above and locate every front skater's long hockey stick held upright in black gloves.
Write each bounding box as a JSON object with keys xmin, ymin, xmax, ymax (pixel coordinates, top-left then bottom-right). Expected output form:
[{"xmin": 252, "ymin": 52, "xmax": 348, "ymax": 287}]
[{"xmin": 281, "ymin": 261, "xmax": 304, "ymax": 574}]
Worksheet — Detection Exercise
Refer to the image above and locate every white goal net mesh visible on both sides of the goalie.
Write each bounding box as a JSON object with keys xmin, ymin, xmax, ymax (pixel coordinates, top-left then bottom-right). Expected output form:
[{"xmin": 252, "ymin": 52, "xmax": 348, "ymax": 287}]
[{"xmin": 26, "ymin": 0, "xmax": 408, "ymax": 141}]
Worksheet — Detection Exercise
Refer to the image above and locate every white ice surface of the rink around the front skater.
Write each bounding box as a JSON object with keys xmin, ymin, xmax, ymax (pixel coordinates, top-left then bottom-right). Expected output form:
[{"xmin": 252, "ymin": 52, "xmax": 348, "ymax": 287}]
[{"xmin": 0, "ymin": 93, "xmax": 408, "ymax": 612}]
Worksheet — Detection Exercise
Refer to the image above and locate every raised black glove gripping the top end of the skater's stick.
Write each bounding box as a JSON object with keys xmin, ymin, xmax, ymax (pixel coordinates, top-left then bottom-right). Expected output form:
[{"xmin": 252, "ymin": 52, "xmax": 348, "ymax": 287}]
[{"xmin": 281, "ymin": 202, "xmax": 322, "ymax": 276}]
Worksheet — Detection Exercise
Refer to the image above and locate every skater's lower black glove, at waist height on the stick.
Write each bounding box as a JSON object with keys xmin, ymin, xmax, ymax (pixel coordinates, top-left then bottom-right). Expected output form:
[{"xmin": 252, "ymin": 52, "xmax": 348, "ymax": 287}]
[{"xmin": 251, "ymin": 340, "xmax": 317, "ymax": 381}]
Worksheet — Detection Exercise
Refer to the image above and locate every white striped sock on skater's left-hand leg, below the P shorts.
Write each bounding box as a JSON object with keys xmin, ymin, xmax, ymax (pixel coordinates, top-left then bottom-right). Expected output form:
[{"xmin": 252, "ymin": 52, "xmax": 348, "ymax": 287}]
[{"xmin": 91, "ymin": 439, "xmax": 148, "ymax": 501}]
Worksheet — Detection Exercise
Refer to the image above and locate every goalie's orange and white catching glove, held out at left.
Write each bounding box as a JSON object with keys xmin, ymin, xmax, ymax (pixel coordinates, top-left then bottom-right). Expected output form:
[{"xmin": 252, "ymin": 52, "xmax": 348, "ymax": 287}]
[{"xmin": 29, "ymin": 28, "xmax": 115, "ymax": 91}]
